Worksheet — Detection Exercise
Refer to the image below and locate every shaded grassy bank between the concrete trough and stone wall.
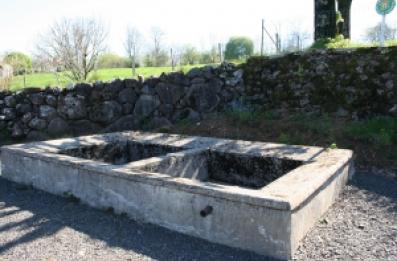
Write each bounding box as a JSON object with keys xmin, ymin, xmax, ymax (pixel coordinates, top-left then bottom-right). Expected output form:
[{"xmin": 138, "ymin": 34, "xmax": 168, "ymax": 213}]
[{"xmin": 171, "ymin": 109, "xmax": 397, "ymax": 167}]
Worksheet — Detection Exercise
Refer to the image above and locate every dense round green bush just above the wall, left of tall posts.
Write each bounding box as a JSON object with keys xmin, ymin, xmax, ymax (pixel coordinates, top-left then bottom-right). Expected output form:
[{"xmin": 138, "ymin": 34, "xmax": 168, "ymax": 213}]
[{"xmin": 225, "ymin": 37, "xmax": 254, "ymax": 59}]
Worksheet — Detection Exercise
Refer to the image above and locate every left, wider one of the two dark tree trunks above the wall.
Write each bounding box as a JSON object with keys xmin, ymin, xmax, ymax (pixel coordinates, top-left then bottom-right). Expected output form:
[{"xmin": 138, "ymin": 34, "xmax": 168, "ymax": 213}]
[{"xmin": 314, "ymin": 0, "xmax": 336, "ymax": 40}]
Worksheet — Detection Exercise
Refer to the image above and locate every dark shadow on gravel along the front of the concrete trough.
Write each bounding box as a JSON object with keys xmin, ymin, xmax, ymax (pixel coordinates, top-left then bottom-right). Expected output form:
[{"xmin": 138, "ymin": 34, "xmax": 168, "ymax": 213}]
[{"xmin": 0, "ymin": 178, "xmax": 276, "ymax": 260}]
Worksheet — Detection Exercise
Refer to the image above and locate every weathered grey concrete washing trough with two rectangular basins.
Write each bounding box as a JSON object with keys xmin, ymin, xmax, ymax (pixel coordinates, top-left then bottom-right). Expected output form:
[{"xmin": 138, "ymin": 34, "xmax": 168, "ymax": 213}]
[{"xmin": 1, "ymin": 132, "xmax": 353, "ymax": 259}]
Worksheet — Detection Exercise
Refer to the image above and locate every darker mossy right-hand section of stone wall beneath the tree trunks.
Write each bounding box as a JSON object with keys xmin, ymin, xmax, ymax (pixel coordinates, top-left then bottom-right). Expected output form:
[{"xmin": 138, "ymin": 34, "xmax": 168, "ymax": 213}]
[{"xmin": 244, "ymin": 47, "xmax": 397, "ymax": 118}]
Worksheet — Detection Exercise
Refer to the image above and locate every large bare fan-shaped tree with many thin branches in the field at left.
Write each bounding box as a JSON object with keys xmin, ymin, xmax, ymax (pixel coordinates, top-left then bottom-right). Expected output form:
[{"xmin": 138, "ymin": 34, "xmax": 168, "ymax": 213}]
[{"xmin": 37, "ymin": 18, "xmax": 107, "ymax": 81}]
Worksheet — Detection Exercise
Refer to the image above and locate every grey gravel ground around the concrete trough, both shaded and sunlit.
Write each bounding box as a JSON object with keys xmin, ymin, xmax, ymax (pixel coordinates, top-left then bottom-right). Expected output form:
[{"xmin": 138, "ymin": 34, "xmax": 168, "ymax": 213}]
[{"xmin": 0, "ymin": 171, "xmax": 397, "ymax": 260}]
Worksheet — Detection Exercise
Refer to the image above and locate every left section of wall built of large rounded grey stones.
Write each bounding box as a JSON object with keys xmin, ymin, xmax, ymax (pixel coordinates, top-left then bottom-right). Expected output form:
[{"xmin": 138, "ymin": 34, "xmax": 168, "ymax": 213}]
[{"xmin": 0, "ymin": 64, "xmax": 244, "ymax": 140}]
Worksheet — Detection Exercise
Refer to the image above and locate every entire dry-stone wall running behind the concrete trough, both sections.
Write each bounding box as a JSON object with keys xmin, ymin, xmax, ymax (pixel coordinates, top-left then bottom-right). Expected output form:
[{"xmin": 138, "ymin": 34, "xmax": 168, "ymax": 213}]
[{"xmin": 0, "ymin": 47, "xmax": 397, "ymax": 139}]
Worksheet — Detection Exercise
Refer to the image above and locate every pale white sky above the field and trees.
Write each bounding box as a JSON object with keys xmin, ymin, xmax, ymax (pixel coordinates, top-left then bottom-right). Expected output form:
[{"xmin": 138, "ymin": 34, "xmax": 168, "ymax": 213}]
[{"xmin": 0, "ymin": 0, "xmax": 397, "ymax": 55}]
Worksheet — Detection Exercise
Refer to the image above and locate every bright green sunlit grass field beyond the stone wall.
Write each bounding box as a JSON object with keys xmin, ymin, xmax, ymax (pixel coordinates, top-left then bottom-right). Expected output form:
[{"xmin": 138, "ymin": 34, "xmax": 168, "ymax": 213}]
[{"xmin": 10, "ymin": 64, "xmax": 204, "ymax": 91}]
